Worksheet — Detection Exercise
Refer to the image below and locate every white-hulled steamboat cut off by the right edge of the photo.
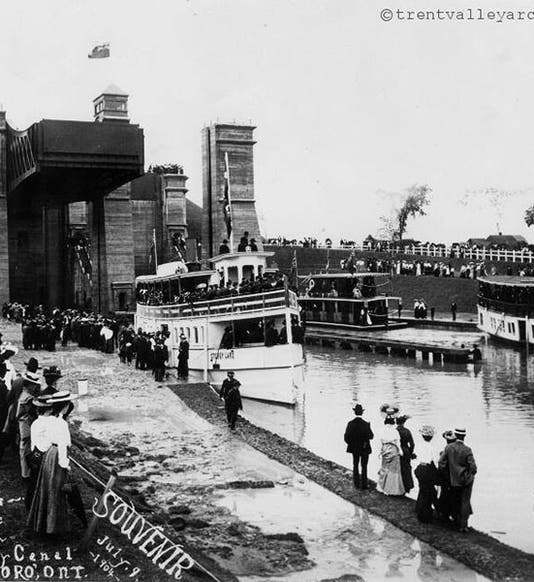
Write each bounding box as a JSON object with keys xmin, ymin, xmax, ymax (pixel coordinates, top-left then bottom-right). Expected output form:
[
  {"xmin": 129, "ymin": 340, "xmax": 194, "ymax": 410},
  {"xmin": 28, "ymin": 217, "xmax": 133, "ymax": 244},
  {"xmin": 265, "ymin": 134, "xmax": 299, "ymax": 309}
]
[{"xmin": 477, "ymin": 276, "xmax": 534, "ymax": 344}]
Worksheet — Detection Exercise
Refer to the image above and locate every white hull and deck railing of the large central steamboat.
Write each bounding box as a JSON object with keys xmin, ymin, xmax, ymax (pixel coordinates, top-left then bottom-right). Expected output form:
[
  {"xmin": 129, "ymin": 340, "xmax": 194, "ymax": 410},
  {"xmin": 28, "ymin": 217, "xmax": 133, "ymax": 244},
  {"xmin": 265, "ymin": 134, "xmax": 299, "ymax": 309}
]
[{"xmin": 135, "ymin": 289, "xmax": 304, "ymax": 404}]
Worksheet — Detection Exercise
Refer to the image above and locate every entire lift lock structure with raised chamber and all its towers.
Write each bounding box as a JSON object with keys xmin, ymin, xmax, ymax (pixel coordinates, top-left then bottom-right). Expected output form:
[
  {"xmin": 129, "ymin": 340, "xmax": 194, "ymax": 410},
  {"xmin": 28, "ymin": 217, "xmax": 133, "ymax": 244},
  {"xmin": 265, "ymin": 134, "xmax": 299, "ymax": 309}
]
[{"xmin": 0, "ymin": 85, "xmax": 262, "ymax": 313}]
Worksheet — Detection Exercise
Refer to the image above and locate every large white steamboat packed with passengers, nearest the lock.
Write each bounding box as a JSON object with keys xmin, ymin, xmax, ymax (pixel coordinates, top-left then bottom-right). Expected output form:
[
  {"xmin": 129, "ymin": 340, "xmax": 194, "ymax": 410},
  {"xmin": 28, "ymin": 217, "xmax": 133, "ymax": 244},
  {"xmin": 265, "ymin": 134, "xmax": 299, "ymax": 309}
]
[{"xmin": 135, "ymin": 251, "xmax": 304, "ymax": 405}]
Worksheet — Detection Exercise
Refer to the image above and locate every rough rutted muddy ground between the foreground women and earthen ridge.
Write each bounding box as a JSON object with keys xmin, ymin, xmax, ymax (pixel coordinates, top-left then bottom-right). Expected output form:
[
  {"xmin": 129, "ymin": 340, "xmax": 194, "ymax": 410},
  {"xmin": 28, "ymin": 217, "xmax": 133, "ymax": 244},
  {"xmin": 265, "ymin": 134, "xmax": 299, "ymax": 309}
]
[{"xmin": 0, "ymin": 322, "xmax": 314, "ymax": 582}]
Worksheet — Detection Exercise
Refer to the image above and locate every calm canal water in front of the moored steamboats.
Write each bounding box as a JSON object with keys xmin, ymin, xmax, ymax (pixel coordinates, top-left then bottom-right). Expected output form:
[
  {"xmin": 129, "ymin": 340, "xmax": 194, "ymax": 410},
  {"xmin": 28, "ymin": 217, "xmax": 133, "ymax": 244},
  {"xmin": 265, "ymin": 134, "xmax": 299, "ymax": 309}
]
[{"xmin": 244, "ymin": 329, "xmax": 534, "ymax": 552}]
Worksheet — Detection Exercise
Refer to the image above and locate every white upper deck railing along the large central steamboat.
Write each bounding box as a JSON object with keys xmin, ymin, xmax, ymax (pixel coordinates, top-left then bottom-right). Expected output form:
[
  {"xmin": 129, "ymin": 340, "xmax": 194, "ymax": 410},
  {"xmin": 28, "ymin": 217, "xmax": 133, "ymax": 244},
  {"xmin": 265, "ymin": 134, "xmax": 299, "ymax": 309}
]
[{"xmin": 137, "ymin": 289, "xmax": 298, "ymax": 319}]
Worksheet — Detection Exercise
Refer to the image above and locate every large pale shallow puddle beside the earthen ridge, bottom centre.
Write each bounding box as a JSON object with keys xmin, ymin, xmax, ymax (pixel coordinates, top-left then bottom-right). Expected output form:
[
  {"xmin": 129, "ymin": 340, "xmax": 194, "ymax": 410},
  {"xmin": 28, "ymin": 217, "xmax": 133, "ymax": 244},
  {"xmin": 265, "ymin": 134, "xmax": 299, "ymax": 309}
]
[{"xmin": 217, "ymin": 480, "xmax": 487, "ymax": 582}]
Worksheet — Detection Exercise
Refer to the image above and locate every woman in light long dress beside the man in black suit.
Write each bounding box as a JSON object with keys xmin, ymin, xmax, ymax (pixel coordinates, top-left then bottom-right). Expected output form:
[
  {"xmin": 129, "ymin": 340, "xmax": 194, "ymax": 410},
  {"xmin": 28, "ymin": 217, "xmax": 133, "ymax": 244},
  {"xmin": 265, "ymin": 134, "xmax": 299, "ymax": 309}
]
[{"xmin": 378, "ymin": 408, "xmax": 405, "ymax": 495}]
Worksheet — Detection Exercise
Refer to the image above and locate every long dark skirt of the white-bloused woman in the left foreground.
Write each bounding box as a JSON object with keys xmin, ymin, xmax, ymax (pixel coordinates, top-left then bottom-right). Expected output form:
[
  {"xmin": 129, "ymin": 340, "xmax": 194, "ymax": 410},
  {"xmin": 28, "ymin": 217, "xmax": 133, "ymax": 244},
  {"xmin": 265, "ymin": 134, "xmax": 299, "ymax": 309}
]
[{"xmin": 28, "ymin": 445, "xmax": 70, "ymax": 534}]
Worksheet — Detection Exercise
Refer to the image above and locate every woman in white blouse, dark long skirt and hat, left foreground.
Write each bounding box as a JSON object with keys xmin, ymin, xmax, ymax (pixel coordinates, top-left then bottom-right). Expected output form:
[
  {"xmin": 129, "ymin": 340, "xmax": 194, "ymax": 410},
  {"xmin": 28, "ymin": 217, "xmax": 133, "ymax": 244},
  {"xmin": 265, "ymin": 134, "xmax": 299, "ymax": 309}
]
[{"xmin": 28, "ymin": 390, "xmax": 77, "ymax": 534}]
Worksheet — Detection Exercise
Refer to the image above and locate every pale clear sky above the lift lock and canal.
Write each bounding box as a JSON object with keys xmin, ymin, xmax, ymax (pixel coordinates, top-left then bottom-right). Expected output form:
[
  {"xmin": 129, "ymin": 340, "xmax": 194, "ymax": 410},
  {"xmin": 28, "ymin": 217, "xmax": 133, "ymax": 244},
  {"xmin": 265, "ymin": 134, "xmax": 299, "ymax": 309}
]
[{"xmin": 0, "ymin": 0, "xmax": 534, "ymax": 242}]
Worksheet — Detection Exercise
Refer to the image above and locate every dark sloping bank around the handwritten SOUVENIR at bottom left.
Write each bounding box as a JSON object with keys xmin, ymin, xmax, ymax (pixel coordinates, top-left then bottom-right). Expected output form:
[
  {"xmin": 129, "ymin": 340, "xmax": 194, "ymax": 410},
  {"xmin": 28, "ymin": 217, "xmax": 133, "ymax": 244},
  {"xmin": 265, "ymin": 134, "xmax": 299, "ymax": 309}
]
[{"xmin": 0, "ymin": 438, "xmax": 237, "ymax": 582}]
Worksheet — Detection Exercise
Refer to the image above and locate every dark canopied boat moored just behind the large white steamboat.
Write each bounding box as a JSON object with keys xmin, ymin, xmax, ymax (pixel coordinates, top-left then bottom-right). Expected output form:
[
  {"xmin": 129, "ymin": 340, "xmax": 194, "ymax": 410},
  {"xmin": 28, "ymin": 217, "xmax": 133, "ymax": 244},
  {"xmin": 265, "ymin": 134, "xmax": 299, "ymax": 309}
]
[{"xmin": 299, "ymin": 273, "xmax": 399, "ymax": 329}]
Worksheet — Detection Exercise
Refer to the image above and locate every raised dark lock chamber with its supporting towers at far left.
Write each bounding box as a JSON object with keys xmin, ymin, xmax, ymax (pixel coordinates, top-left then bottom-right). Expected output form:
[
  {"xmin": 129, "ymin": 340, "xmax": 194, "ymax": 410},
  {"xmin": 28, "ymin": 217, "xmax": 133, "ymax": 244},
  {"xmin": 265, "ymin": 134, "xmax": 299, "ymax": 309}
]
[{"xmin": 0, "ymin": 86, "xmax": 144, "ymax": 312}]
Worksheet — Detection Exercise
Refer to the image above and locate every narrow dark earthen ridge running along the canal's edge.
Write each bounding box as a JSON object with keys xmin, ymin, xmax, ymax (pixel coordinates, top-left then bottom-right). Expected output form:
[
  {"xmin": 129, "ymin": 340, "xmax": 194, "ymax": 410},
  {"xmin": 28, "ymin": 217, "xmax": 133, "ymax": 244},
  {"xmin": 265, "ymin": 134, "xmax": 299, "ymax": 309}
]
[{"xmin": 171, "ymin": 384, "xmax": 534, "ymax": 581}]
